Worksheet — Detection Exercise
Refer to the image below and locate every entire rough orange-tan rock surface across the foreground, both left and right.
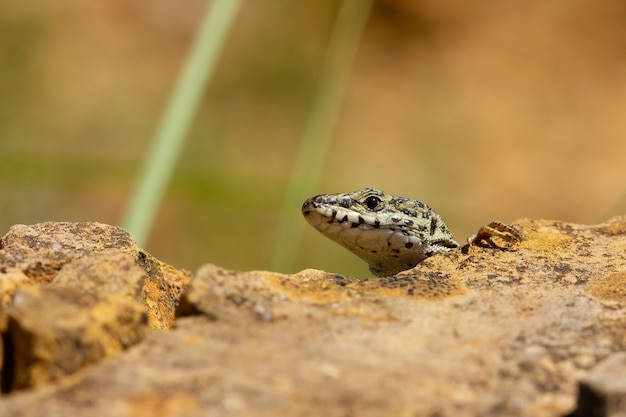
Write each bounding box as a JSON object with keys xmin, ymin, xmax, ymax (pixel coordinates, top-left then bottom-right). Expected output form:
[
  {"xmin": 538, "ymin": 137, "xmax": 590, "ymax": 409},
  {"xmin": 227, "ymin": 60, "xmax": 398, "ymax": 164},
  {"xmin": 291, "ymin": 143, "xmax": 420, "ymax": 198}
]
[{"xmin": 0, "ymin": 217, "xmax": 626, "ymax": 417}]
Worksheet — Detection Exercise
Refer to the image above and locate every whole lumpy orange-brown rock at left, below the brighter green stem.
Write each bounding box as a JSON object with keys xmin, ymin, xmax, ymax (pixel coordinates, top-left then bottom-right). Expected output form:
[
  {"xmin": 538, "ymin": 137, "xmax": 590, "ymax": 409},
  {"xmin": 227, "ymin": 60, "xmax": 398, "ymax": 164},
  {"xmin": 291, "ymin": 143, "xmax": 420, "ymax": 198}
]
[{"xmin": 0, "ymin": 222, "xmax": 188, "ymax": 393}]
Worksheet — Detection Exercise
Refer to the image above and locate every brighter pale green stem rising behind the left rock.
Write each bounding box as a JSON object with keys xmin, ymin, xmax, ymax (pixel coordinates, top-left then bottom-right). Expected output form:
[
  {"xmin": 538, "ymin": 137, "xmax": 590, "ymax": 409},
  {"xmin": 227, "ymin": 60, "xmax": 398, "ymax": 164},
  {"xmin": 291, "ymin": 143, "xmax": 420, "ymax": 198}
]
[{"xmin": 122, "ymin": 0, "xmax": 241, "ymax": 246}]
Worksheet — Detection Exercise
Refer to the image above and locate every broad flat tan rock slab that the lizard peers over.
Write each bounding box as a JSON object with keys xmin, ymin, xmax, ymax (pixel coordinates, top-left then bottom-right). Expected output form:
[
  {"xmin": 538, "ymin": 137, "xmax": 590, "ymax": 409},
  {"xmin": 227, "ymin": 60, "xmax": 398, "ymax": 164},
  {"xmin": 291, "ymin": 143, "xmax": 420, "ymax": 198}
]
[{"xmin": 0, "ymin": 217, "xmax": 626, "ymax": 417}]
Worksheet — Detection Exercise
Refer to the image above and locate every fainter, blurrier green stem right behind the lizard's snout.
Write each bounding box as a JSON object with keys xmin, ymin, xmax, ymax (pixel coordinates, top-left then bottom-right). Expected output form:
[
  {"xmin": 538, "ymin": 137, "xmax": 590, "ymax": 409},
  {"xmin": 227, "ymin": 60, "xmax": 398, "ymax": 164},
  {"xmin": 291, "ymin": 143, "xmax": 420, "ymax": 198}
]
[{"xmin": 269, "ymin": 0, "xmax": 373, "ymax": 271}]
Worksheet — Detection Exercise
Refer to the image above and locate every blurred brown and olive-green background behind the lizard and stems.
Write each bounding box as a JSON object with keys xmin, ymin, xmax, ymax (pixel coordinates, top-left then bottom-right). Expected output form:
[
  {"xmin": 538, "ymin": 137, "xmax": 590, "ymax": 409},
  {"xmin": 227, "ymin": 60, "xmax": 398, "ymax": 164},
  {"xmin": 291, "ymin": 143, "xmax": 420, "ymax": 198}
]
[{"xmin": 0, "ymin": 0, "xmax": 626, "ymax": 277}]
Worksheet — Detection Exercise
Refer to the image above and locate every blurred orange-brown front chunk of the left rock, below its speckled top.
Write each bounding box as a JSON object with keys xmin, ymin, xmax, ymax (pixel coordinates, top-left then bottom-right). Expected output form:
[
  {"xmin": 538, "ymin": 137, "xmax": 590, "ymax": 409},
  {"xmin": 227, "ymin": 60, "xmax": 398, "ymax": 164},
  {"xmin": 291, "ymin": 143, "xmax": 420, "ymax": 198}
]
[{"xmin": 2, "ymin": 282, "xmax": 148, "ymax": 392}]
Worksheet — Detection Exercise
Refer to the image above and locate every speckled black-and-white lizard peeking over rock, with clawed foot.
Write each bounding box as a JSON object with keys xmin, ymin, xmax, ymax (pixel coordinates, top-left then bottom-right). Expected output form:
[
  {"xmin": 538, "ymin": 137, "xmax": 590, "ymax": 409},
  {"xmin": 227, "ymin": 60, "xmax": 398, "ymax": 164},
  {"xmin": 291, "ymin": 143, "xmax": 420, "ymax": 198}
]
[{"xmin": 302, "ymin": 188, "xmax": 522, "ymax": 277}]
